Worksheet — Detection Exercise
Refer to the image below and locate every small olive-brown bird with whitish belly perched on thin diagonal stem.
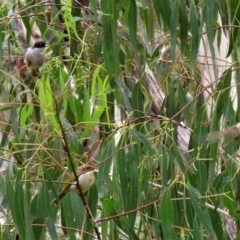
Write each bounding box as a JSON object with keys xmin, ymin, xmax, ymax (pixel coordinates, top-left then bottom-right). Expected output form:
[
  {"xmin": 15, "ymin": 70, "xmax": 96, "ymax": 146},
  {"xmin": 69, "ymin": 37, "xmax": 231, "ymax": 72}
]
[{"xmin": 52, "ymin": 164, "xmax": 95, "ymax": 205}]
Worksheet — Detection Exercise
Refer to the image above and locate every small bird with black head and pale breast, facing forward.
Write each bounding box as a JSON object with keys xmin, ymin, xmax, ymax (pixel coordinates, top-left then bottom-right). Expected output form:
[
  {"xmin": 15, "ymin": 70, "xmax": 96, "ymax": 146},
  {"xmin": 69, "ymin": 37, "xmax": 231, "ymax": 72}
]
[{"xmin": 25, "ymin": 41, "xmax": 48, "ymax": 69}]
